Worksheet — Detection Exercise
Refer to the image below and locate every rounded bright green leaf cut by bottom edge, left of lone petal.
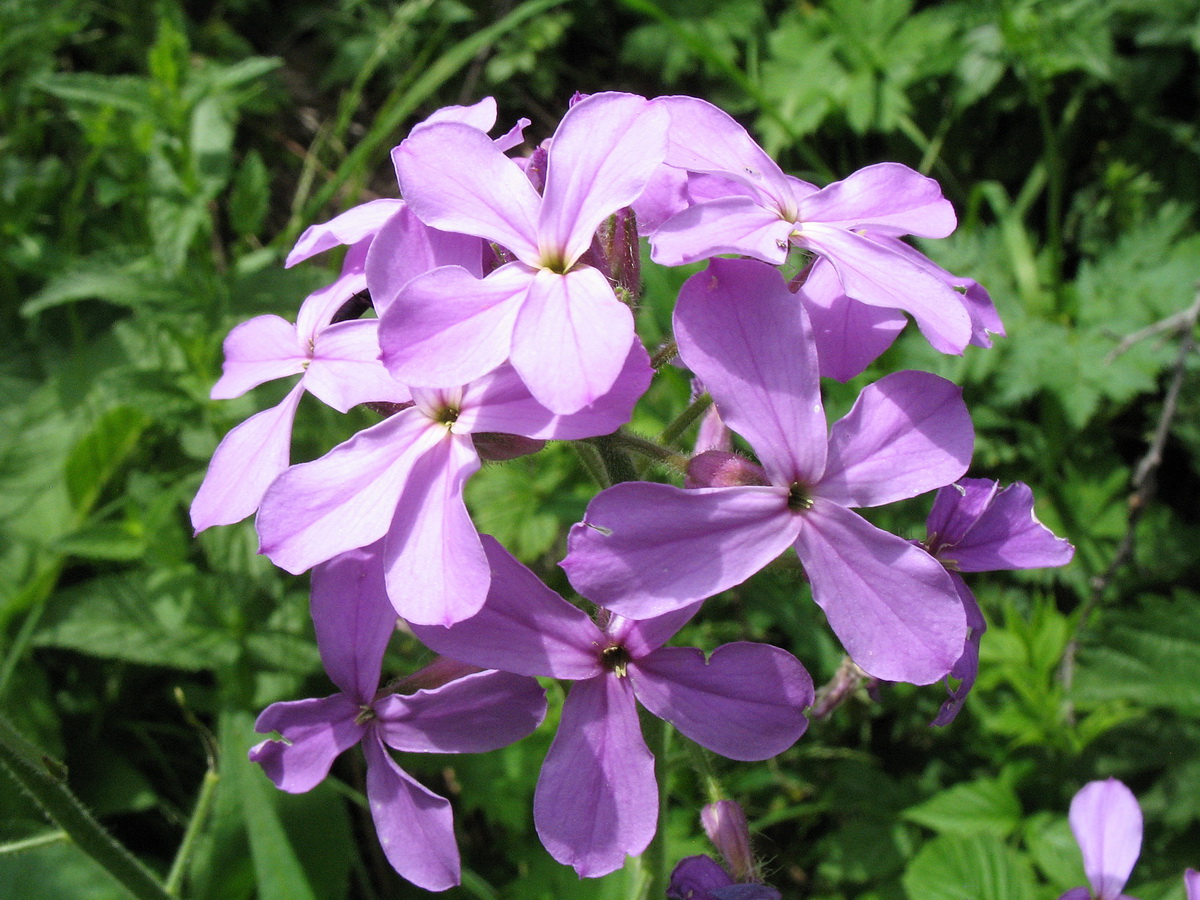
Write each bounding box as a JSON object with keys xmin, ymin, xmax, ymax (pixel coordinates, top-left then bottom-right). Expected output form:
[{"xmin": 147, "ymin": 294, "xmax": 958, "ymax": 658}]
[{"xmin": 902, "ymin": 834, "xmax": 1038, "ymax": 900}]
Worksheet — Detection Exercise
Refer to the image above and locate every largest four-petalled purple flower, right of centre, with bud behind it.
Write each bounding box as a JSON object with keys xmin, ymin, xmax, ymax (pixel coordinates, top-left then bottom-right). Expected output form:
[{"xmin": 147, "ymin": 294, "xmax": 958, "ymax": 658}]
[{"xmin": 563, "ymin": 259, "xmax": 973, "ymax": 684}]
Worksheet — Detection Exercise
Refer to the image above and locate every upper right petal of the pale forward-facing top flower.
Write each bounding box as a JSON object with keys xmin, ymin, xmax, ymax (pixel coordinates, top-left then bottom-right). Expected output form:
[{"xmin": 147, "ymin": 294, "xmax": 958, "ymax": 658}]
[{"xmin": 538, "ymin": 92, "xmax": 670, "ymax": 265}]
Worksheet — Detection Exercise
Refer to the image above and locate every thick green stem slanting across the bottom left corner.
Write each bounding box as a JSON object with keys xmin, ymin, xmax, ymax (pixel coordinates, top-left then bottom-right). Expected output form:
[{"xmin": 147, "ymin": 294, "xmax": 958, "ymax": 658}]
[{"xmin": 0, "ymin": 715, "xmax": 170, "ymax": 900}]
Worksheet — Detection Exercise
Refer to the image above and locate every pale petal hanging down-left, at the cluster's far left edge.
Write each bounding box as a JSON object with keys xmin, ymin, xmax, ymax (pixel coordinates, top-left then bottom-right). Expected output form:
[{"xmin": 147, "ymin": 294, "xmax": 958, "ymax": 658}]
[{"xmin": 191, "ymin": 382, "xmax": 304, "ymax": 534}]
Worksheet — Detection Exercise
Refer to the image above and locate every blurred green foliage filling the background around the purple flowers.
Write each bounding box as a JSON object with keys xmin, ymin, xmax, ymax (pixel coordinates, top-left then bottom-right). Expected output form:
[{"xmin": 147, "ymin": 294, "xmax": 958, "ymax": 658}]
[{"xmin": 0, "ymin": 0, "xmax": 1200, "ymax": 900}]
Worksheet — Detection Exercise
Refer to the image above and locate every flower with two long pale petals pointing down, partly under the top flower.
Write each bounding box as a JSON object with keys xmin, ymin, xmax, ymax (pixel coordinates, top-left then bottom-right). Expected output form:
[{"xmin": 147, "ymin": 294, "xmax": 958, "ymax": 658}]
[{"xmin": 257, "ymin": 342, "xmax": 650, "ymax": 624}]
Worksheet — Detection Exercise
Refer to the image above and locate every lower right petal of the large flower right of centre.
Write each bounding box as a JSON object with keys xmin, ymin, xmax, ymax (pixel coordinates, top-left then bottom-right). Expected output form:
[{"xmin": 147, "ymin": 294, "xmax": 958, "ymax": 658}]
[{"xmin": 796, "ymin": 497, "xmax": 967, "ymax": 684}]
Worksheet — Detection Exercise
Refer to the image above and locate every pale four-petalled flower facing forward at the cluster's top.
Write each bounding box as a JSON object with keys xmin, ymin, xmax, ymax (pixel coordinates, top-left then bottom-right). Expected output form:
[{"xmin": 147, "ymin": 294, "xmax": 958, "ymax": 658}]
[{"xmin": 380, "ymin": 94, "xmax": 667, "ymax": 414}]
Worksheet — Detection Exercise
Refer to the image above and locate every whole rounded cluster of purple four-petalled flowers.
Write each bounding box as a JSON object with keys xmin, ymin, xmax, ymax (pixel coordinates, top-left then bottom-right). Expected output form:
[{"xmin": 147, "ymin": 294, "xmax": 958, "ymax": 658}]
[{"xmin": 192, "ymin": 92, "xmax": 1072, "ymax": 895}]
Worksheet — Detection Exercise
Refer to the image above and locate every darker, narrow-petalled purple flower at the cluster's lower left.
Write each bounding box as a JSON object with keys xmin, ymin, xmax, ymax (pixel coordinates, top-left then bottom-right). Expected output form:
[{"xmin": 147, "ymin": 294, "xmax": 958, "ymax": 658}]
[{"xmin": 250, "ymin": 548, "xmax": 546, "ymax": 890}]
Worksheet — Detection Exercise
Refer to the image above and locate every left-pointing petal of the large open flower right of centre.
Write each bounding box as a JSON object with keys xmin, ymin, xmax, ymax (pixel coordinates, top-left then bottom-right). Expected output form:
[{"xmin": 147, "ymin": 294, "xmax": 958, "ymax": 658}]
[{"xmin": 560, "ymin": 481, "xmax": 801, "ymax": 619}]
